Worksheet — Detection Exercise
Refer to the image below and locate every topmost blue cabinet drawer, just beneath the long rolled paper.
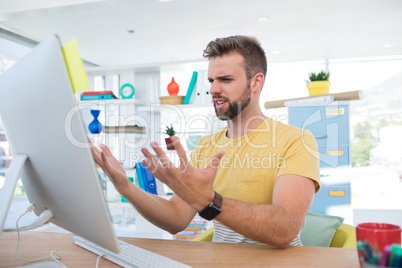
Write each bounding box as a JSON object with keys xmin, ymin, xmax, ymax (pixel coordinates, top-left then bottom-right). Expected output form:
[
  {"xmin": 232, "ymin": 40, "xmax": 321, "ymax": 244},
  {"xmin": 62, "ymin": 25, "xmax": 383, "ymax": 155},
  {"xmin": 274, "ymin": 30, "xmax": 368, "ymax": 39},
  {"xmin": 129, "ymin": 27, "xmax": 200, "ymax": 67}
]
[{"xmin": 289, "ymin": 105, "xmax": 349, "ymax": 145}]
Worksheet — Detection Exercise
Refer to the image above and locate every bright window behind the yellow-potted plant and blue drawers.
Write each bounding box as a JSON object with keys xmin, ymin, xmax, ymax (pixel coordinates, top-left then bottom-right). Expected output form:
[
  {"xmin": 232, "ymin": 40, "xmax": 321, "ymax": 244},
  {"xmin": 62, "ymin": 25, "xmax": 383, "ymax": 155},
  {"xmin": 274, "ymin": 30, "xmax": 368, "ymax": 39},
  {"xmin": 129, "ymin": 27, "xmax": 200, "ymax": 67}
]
[{"xmin": 260, "ymin": 56, "xmax": 402, "ymax": 209}]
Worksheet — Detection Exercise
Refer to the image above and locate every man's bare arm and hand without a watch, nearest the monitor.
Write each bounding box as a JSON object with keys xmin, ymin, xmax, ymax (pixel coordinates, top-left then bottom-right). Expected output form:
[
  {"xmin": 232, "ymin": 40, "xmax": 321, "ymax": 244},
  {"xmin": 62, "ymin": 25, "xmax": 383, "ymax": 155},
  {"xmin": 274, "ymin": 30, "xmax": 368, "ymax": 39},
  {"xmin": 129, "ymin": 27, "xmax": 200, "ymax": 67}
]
[{"xmin": 91, "ymin": 143, "xmax": 197, "ymax": 234}]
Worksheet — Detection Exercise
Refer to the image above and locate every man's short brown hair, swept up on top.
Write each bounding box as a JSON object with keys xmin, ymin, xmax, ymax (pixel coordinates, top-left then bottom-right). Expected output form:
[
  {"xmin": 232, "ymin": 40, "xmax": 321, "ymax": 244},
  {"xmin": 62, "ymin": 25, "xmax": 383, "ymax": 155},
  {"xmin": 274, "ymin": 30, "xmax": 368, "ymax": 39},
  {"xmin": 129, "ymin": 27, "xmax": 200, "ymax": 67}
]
[{"xmin": 203, "ymin": 35, "xmax": 267, "ymax": 79}]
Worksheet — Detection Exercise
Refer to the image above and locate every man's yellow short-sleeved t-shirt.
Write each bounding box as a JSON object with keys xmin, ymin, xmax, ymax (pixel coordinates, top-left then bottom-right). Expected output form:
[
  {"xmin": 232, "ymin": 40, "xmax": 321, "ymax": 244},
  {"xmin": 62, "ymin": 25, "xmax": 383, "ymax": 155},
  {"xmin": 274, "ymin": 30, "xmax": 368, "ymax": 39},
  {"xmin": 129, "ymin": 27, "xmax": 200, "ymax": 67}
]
[{"xmin": 190, "ymin": 118, "xmax": 320, "ymax": 204}]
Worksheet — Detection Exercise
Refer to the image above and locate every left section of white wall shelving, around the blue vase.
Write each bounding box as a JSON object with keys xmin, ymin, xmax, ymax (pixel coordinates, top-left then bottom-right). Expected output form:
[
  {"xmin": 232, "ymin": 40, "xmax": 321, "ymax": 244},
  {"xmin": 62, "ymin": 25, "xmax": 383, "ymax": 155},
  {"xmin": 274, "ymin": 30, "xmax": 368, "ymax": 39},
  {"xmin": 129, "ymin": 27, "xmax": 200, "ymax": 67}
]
[{"xmin": 81, "ymin": 67, "xmax": 160, "ymax": 168}]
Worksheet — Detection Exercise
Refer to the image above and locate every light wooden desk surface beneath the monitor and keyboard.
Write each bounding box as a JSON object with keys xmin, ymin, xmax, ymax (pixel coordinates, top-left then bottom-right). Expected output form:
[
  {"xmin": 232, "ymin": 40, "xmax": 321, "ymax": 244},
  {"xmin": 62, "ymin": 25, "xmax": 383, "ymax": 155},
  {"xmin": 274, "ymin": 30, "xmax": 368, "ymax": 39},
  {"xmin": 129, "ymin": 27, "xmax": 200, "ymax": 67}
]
[{"xmin": 0, "ymin": 231, "xmax": 359, "ymax": 268}]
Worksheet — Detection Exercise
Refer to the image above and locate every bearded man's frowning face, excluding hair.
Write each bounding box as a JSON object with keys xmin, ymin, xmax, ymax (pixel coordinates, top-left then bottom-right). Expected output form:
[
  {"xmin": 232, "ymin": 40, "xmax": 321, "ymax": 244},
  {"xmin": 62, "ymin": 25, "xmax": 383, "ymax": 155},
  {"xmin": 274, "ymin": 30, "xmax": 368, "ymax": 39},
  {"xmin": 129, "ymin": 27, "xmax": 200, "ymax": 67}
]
[{"xmin": 208, "ymin": 53, "xmax": 251, "ymax": 120}]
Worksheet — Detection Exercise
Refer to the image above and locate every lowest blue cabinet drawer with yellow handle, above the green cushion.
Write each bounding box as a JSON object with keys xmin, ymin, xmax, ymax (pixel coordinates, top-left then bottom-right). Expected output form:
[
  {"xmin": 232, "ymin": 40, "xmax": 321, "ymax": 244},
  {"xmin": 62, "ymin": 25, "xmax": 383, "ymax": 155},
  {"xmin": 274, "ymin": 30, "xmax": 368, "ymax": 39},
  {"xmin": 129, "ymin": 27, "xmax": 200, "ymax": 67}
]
[{"xmin": 310, "ymin": 186, "xmax": 350, "ymax": 214}]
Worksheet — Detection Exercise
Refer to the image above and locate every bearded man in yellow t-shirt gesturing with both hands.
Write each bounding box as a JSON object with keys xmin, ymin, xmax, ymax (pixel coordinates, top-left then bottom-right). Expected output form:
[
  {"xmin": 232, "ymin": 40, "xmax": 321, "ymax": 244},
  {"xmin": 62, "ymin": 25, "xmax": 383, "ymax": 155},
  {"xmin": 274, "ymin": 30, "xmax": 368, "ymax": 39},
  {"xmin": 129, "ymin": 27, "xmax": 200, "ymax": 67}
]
[{"xmin": 93, "ymin": 36, "xmax": 320, "ymax": 248}]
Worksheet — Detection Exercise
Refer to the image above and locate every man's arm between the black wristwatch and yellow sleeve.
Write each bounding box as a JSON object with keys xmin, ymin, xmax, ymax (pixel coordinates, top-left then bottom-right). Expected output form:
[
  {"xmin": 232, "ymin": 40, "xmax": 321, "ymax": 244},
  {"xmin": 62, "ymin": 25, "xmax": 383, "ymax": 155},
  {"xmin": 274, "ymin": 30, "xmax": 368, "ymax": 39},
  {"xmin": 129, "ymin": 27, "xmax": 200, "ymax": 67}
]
[{"xmin": 215, "ymin": 175, "xmax": 315, "ymax": 248}]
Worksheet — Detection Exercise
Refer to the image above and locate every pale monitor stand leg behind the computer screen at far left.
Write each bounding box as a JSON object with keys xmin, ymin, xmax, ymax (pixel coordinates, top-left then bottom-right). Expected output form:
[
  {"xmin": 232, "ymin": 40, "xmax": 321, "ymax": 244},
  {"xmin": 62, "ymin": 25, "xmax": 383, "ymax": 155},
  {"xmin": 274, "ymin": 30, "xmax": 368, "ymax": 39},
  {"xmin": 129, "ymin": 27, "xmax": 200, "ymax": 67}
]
[{"xmin": 0, "ymin": 154, "xmax": 28, "ymax": 237}]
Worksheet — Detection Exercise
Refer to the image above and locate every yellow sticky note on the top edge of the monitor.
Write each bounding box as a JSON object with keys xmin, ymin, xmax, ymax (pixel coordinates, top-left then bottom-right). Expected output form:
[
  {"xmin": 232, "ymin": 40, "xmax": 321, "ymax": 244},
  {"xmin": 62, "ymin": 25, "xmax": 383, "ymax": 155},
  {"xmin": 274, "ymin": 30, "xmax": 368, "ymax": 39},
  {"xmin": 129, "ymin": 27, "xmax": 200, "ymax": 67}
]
[{"xmin": 62, "ymin": 39, "xmax": 89, "ymax": 93}]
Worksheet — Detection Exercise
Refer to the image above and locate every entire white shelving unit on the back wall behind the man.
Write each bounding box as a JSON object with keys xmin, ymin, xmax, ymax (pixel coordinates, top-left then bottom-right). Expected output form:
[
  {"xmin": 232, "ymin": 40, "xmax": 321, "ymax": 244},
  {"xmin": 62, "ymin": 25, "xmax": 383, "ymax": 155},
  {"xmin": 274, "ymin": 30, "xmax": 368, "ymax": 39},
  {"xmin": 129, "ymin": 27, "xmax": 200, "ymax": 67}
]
[{"xmin": 77, "ymin": 62, "xmax": 221, "ymax": 167}]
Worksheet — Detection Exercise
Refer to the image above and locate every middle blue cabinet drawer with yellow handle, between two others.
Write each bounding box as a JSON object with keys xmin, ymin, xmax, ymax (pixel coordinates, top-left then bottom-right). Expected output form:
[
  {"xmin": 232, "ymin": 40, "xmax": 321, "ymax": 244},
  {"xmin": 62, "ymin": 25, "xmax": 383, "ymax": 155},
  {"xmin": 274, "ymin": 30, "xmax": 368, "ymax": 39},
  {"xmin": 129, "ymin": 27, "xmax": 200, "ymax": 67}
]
[{"xmin": 318, "ymin": 146, "xmax": 350, "ymax": 168}]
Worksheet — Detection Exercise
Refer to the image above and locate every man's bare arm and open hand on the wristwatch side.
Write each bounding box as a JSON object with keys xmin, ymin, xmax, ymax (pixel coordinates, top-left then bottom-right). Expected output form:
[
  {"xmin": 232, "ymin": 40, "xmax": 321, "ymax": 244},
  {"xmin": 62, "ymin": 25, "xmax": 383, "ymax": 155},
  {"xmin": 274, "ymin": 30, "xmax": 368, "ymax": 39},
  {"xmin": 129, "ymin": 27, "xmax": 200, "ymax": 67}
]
[{"xmin": 142, "ymin": 137, "xmax": 315, "ymax": 248}]
